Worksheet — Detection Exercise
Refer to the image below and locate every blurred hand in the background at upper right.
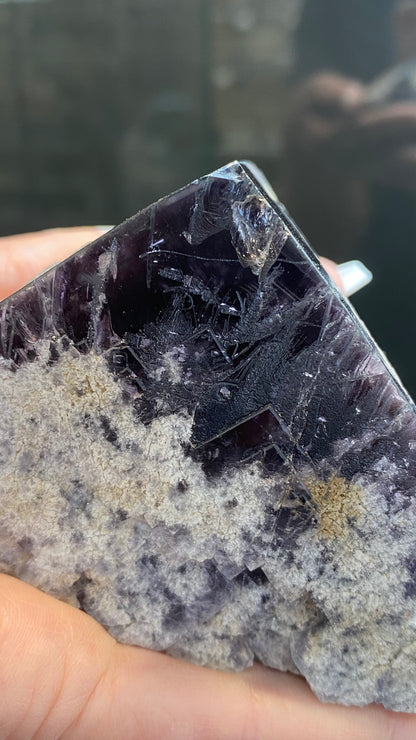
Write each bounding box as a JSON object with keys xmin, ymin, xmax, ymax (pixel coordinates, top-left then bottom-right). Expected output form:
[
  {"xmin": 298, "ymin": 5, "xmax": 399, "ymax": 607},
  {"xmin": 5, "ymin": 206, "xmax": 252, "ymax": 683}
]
[{"xmin": 286, "ymin": 73, "xmax": 416, "ymax": 194}]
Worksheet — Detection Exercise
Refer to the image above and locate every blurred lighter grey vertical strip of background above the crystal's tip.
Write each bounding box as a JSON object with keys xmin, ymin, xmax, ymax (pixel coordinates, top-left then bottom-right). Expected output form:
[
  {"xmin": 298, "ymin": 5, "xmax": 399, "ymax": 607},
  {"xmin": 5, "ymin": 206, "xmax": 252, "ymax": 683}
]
[{"xmin": 211, "ymin": 0, "xmax": 302, "ymax": 168}]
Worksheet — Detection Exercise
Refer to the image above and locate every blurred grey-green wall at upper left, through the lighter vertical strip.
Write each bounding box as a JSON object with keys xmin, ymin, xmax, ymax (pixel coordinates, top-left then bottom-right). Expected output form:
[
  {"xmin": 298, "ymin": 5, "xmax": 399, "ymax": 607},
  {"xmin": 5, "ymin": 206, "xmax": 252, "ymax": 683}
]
[{"xmin": 0, "ymin": 0, "xmax": 300, "ymax": 234}]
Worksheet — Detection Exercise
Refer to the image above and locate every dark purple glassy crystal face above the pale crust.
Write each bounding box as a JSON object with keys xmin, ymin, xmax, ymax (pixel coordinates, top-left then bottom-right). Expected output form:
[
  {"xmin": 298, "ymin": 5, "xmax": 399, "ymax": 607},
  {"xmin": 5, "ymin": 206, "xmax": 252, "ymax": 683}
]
[{"xmin": 1, "ymin": 164, "xmax": 414, "ymax": 477}]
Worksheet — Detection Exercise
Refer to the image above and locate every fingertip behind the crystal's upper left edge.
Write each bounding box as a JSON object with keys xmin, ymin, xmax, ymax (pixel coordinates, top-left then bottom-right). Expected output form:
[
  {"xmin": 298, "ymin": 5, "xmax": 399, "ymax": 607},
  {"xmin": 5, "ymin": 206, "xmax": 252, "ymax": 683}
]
[{"xmin": 0, "ymin": 226, "xmax": 105, "ymax": 300}]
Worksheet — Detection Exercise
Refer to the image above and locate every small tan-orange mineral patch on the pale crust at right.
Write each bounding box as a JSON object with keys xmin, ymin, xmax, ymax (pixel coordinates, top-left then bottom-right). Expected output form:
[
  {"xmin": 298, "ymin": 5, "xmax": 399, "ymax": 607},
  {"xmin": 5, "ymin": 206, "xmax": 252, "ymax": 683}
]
[{"xmin": 305, "ymin": 475, "xmax": 363, "ymax": 540}]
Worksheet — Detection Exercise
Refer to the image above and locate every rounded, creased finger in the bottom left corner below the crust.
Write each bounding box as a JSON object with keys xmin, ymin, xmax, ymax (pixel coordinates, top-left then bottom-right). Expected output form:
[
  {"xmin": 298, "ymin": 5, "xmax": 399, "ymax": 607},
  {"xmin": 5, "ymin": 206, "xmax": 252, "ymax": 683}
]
[{"xmin": 0, "ymin": 575, "xmax": 115, "ymax": 740}]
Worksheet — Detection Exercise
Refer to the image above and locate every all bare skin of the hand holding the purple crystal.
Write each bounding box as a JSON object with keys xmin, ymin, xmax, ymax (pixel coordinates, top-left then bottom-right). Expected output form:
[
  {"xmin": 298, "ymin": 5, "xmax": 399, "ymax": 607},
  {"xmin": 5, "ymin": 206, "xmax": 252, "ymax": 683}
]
[{"xmin": 0, "ymin": 227, "xmax": 416, "ymax": 740}]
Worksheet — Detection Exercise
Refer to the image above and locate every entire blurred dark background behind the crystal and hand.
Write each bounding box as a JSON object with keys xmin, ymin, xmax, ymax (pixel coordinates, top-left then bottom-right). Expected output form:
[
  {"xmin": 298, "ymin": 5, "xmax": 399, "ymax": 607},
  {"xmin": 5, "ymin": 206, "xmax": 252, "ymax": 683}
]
[{"xmin": 0, "ymin": 0, "xmax": 416, "ymax": 396}]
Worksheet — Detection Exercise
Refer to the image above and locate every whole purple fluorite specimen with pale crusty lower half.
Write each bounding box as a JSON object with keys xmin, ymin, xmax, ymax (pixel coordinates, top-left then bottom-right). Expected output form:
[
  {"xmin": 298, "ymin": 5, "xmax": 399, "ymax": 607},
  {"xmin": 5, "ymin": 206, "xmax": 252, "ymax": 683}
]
[{"xmin": 0, "ymin": 163, "xmax": 416, "ymax": 711}]
